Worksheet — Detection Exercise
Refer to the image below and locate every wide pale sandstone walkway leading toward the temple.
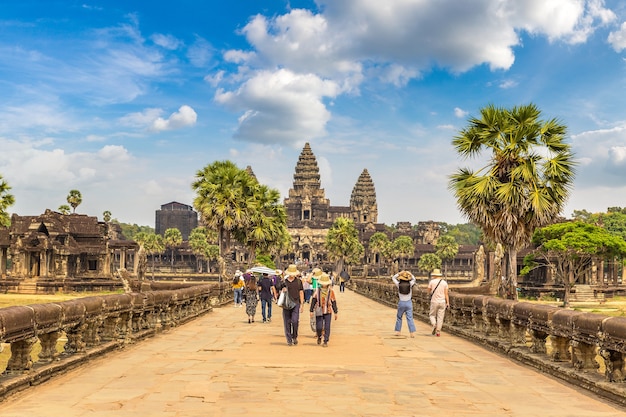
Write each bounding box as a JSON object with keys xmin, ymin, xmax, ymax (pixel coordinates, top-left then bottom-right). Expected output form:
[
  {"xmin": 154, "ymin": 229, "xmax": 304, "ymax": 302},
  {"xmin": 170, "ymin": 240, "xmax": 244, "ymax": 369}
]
[{"xmin": 0, "ymin": 290, "xmax": 625, "ymax": 417}]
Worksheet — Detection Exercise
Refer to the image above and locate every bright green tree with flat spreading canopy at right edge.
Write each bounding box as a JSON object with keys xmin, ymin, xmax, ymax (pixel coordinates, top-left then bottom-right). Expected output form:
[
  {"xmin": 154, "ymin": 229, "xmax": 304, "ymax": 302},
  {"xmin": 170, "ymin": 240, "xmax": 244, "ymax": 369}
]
[{"xmin": 522, "ymin": 221, "xmax": 626, "ymax": 307}]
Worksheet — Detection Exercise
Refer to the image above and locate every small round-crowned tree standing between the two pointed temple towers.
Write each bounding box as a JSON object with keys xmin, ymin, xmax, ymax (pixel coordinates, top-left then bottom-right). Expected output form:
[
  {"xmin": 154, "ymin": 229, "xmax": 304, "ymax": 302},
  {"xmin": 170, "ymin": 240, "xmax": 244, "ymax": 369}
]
[{"xmin": 324, "ymin": 217, "xmax": 365, "ymax": 272}]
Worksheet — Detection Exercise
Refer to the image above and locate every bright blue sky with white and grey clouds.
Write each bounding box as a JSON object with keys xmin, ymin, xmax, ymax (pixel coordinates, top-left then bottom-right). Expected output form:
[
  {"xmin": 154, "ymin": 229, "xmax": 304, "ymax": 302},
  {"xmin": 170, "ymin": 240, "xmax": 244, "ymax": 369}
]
[{"xmin": 0, "ymin": 0, "xmax": 626, "ymax": 227}]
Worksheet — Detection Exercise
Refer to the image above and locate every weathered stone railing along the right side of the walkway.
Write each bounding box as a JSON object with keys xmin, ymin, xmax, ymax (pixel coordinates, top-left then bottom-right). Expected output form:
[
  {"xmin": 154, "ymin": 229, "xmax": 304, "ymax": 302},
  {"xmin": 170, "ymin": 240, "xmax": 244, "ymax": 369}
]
[{"xmin": 349, "ymin": 278, "xmax": 626, "ymax": 406}]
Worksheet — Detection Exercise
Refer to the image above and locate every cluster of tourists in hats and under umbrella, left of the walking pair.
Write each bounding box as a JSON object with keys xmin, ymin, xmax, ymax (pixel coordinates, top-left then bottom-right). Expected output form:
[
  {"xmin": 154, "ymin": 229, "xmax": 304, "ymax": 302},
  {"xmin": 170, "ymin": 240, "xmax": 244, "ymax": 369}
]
[{"xmin": 232, "ymin": 264, "xmax": 338, "ymax": 347}]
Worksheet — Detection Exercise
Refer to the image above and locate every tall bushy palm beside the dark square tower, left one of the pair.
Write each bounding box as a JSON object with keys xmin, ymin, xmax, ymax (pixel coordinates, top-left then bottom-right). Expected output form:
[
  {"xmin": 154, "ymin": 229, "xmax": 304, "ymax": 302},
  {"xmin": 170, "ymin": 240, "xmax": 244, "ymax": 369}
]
[{"xmin": 192, "ymin": 161, "xmax": 258, "ymax": 276}]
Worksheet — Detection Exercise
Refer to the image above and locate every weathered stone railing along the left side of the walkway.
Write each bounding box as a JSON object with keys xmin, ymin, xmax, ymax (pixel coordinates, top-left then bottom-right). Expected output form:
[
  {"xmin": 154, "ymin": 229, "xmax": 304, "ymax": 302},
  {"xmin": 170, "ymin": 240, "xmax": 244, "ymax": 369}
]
[{"xmin": 0, "ymin": 283, "xmax": 233, "ymax": 401}]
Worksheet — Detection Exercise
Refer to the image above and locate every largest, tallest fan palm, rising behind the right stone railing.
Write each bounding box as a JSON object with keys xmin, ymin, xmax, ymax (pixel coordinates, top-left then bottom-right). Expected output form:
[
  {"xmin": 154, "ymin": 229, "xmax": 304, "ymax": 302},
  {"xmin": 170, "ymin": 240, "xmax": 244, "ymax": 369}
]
[{"xmin": 449, "ymin": 104, "xmax": 575, "ymax": 299}]
